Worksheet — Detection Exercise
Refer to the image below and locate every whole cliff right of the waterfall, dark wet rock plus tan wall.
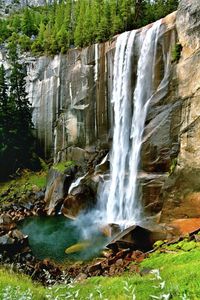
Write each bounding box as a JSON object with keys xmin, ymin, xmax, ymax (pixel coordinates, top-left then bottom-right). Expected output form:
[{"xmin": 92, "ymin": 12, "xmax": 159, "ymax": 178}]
[{"xmin": 138, "ymin": 0, "xmax": 200, "ymax": 222}]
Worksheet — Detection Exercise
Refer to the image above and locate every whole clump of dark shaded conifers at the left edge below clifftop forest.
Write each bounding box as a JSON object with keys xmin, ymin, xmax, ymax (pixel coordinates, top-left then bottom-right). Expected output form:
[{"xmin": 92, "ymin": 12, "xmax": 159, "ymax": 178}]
[{"xmin": 0, "ymin": 42, "xmax": 34, "ymax": 179}]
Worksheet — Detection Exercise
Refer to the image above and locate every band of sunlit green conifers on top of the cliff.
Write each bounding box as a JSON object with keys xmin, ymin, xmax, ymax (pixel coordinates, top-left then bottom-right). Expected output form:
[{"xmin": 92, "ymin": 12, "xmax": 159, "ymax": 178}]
[{"xmin": 0, "ymin": 0, "xmax": 178, "ymax": 54}]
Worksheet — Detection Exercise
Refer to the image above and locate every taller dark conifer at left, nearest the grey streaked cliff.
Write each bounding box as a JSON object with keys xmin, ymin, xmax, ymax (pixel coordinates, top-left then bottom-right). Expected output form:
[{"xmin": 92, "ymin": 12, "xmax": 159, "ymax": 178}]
[{"xmin": 9, "ymin": 42, "xmax": 33, "ymax": 173}]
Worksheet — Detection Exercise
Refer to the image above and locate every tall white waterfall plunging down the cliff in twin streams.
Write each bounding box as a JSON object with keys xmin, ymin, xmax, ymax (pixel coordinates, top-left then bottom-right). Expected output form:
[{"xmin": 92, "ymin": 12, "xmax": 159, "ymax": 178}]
[{"xmin": 99, "ymin": 21, "xmax": 169, "ymax": 224}]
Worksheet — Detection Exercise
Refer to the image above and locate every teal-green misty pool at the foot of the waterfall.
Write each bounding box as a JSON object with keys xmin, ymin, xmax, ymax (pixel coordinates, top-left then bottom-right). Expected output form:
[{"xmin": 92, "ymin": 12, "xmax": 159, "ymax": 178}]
[{"xmin": 19, "ymin": 216, "xmax": 107, "ymax": 261}]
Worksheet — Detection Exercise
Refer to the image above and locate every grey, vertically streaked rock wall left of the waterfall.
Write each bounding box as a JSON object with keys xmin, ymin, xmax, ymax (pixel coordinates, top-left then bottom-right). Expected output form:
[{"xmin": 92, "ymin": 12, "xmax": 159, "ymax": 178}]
[{"xmin": 27, "ymin": 42, "xmax": 114, "ymax": 160}]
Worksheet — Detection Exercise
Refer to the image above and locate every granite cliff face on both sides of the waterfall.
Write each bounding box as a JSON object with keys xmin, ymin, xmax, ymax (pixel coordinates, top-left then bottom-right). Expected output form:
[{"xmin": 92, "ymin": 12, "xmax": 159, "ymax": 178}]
[{"xmin": 1, "ymin": 0, "xmax": 200, "ymax": 221}]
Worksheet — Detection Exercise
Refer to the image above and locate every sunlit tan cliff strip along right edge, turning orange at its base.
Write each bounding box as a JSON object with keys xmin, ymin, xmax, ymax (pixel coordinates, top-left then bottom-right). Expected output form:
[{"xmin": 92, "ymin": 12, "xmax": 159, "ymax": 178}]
[{"xmin": 161, "ymin": 0, "xmax": 200, "ymax": 220}]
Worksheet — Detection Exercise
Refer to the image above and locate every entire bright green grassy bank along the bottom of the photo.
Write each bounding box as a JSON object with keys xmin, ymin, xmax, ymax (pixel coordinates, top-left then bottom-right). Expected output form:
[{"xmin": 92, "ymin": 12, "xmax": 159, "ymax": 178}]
[{"xmin": 0, "ymin": 248, "xmax": 200, "ymax": 300}]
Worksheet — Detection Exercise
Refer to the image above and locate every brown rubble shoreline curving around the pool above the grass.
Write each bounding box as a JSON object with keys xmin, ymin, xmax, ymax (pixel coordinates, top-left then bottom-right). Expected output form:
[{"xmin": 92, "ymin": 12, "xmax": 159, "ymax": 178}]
[{"xmin": 0, "ymin": 188, "xmax": 200, "ymax": 285}]
